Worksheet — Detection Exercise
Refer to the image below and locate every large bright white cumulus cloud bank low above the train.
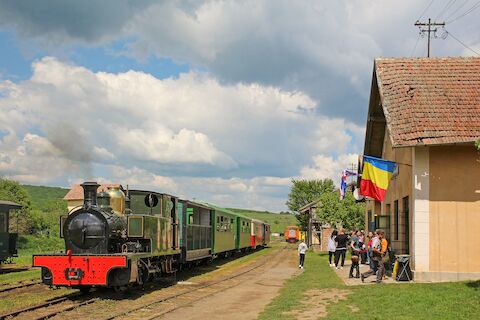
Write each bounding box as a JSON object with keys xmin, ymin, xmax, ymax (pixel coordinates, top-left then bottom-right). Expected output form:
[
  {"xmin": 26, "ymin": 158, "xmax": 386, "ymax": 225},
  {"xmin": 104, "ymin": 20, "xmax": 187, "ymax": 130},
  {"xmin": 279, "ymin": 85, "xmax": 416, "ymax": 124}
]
[{"xmin": 0, "ymin": 57, "xmax": 361, "ymax": 210}]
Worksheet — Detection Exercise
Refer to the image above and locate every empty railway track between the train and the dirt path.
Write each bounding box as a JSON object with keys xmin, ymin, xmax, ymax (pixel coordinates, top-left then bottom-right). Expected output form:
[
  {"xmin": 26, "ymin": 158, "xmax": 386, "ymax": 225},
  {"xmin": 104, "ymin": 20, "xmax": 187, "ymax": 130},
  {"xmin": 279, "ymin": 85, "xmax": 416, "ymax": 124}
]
[{"xmin": 103, "ymin": 246, "xmax": 287, "ymax": 320}]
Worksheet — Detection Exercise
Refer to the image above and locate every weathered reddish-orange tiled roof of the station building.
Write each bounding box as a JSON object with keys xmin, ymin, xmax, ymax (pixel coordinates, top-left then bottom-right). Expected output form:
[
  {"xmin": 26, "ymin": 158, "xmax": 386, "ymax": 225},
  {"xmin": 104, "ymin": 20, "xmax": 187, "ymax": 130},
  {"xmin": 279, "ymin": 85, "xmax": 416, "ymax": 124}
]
[{"xmin": 375, "ymin": 57, "xmax": 480, "ymax": 146}]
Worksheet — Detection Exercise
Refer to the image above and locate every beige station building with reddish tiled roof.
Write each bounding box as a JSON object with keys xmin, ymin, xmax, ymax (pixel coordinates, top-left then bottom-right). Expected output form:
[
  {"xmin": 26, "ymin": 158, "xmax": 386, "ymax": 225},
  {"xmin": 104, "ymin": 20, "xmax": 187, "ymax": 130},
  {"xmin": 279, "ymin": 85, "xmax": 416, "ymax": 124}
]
[{"xmin": 364, "ymin": 57, "xmax": 480, "ymax": 281}]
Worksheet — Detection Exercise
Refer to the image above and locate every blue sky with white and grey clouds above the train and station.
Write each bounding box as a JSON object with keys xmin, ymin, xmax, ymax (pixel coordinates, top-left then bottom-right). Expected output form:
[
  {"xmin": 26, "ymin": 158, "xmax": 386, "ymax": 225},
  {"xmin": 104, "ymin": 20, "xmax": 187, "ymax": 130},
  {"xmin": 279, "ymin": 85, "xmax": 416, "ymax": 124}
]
[{"xmin": 0, "ymin": 0, "xmax": 480, "ymax": 211}]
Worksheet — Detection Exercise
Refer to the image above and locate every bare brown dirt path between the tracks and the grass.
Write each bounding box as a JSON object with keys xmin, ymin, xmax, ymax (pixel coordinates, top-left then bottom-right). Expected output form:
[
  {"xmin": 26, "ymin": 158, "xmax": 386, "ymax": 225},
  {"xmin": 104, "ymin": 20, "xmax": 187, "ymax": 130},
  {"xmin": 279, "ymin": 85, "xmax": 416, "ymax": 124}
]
[{"xmin": 161, "ymin": 249, "xmax": 299, "ymax": 320}]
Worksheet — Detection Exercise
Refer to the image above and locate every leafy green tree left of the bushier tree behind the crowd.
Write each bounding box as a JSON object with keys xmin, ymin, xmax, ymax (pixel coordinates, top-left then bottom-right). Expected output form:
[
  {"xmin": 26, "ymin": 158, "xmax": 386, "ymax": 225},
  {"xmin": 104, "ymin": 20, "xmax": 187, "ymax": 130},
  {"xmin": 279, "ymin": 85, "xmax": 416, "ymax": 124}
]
[{"xmin": 286, "ymin": 179, "xmax": 335, "ymax": 230}]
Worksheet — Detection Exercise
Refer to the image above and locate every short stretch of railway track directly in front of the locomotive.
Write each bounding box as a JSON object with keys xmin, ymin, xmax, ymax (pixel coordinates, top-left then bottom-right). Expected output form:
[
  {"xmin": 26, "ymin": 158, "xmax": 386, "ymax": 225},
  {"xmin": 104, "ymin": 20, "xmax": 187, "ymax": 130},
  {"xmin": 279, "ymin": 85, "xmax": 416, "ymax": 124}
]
[{"xmin": 0, "ymin": 293, "xmax": 98, "ymax": 320}]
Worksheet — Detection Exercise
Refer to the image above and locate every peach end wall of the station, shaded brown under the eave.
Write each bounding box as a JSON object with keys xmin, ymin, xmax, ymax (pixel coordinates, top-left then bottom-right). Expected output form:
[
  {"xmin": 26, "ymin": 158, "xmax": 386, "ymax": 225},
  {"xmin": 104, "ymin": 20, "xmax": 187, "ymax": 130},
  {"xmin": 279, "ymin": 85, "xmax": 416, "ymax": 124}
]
[{"xmin": 429, "ymin": 144, "xmax": 480, "ymax": 280}]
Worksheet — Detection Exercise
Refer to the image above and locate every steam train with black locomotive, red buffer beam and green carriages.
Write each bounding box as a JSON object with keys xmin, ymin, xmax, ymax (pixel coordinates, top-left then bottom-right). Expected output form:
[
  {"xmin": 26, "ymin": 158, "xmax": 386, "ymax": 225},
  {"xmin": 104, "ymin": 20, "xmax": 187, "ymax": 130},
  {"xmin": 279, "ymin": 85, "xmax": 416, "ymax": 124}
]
[{"xmin": 33, "ymin": 182, "xmax": 270, "ymax": 291}]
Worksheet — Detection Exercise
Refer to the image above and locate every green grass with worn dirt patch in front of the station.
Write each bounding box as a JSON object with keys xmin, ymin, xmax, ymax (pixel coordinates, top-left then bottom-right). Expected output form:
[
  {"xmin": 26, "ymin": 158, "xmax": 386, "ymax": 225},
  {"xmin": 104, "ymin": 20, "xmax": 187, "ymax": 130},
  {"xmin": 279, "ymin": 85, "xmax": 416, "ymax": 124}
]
[{"xmin": 259, "ymin": 253, "xmax": 480, "ymax": 320}]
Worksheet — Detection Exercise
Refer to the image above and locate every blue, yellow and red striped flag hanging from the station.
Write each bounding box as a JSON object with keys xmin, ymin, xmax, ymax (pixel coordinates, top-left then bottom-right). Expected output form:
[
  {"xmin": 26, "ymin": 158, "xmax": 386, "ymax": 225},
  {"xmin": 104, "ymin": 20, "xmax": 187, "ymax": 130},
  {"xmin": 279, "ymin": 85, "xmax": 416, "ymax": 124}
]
[{"xmin": 360, "ymin": 156, "xmax": 397, "ymax": 201}]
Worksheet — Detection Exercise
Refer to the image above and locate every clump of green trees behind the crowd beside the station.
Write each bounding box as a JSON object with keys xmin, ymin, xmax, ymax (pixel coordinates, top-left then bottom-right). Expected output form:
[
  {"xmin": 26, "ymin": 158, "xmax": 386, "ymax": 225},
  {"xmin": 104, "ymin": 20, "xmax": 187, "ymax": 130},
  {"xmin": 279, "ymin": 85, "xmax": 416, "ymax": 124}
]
[{"xmin": 286, "ymin": 179, "xmax": 365, "ymax": 230}]
